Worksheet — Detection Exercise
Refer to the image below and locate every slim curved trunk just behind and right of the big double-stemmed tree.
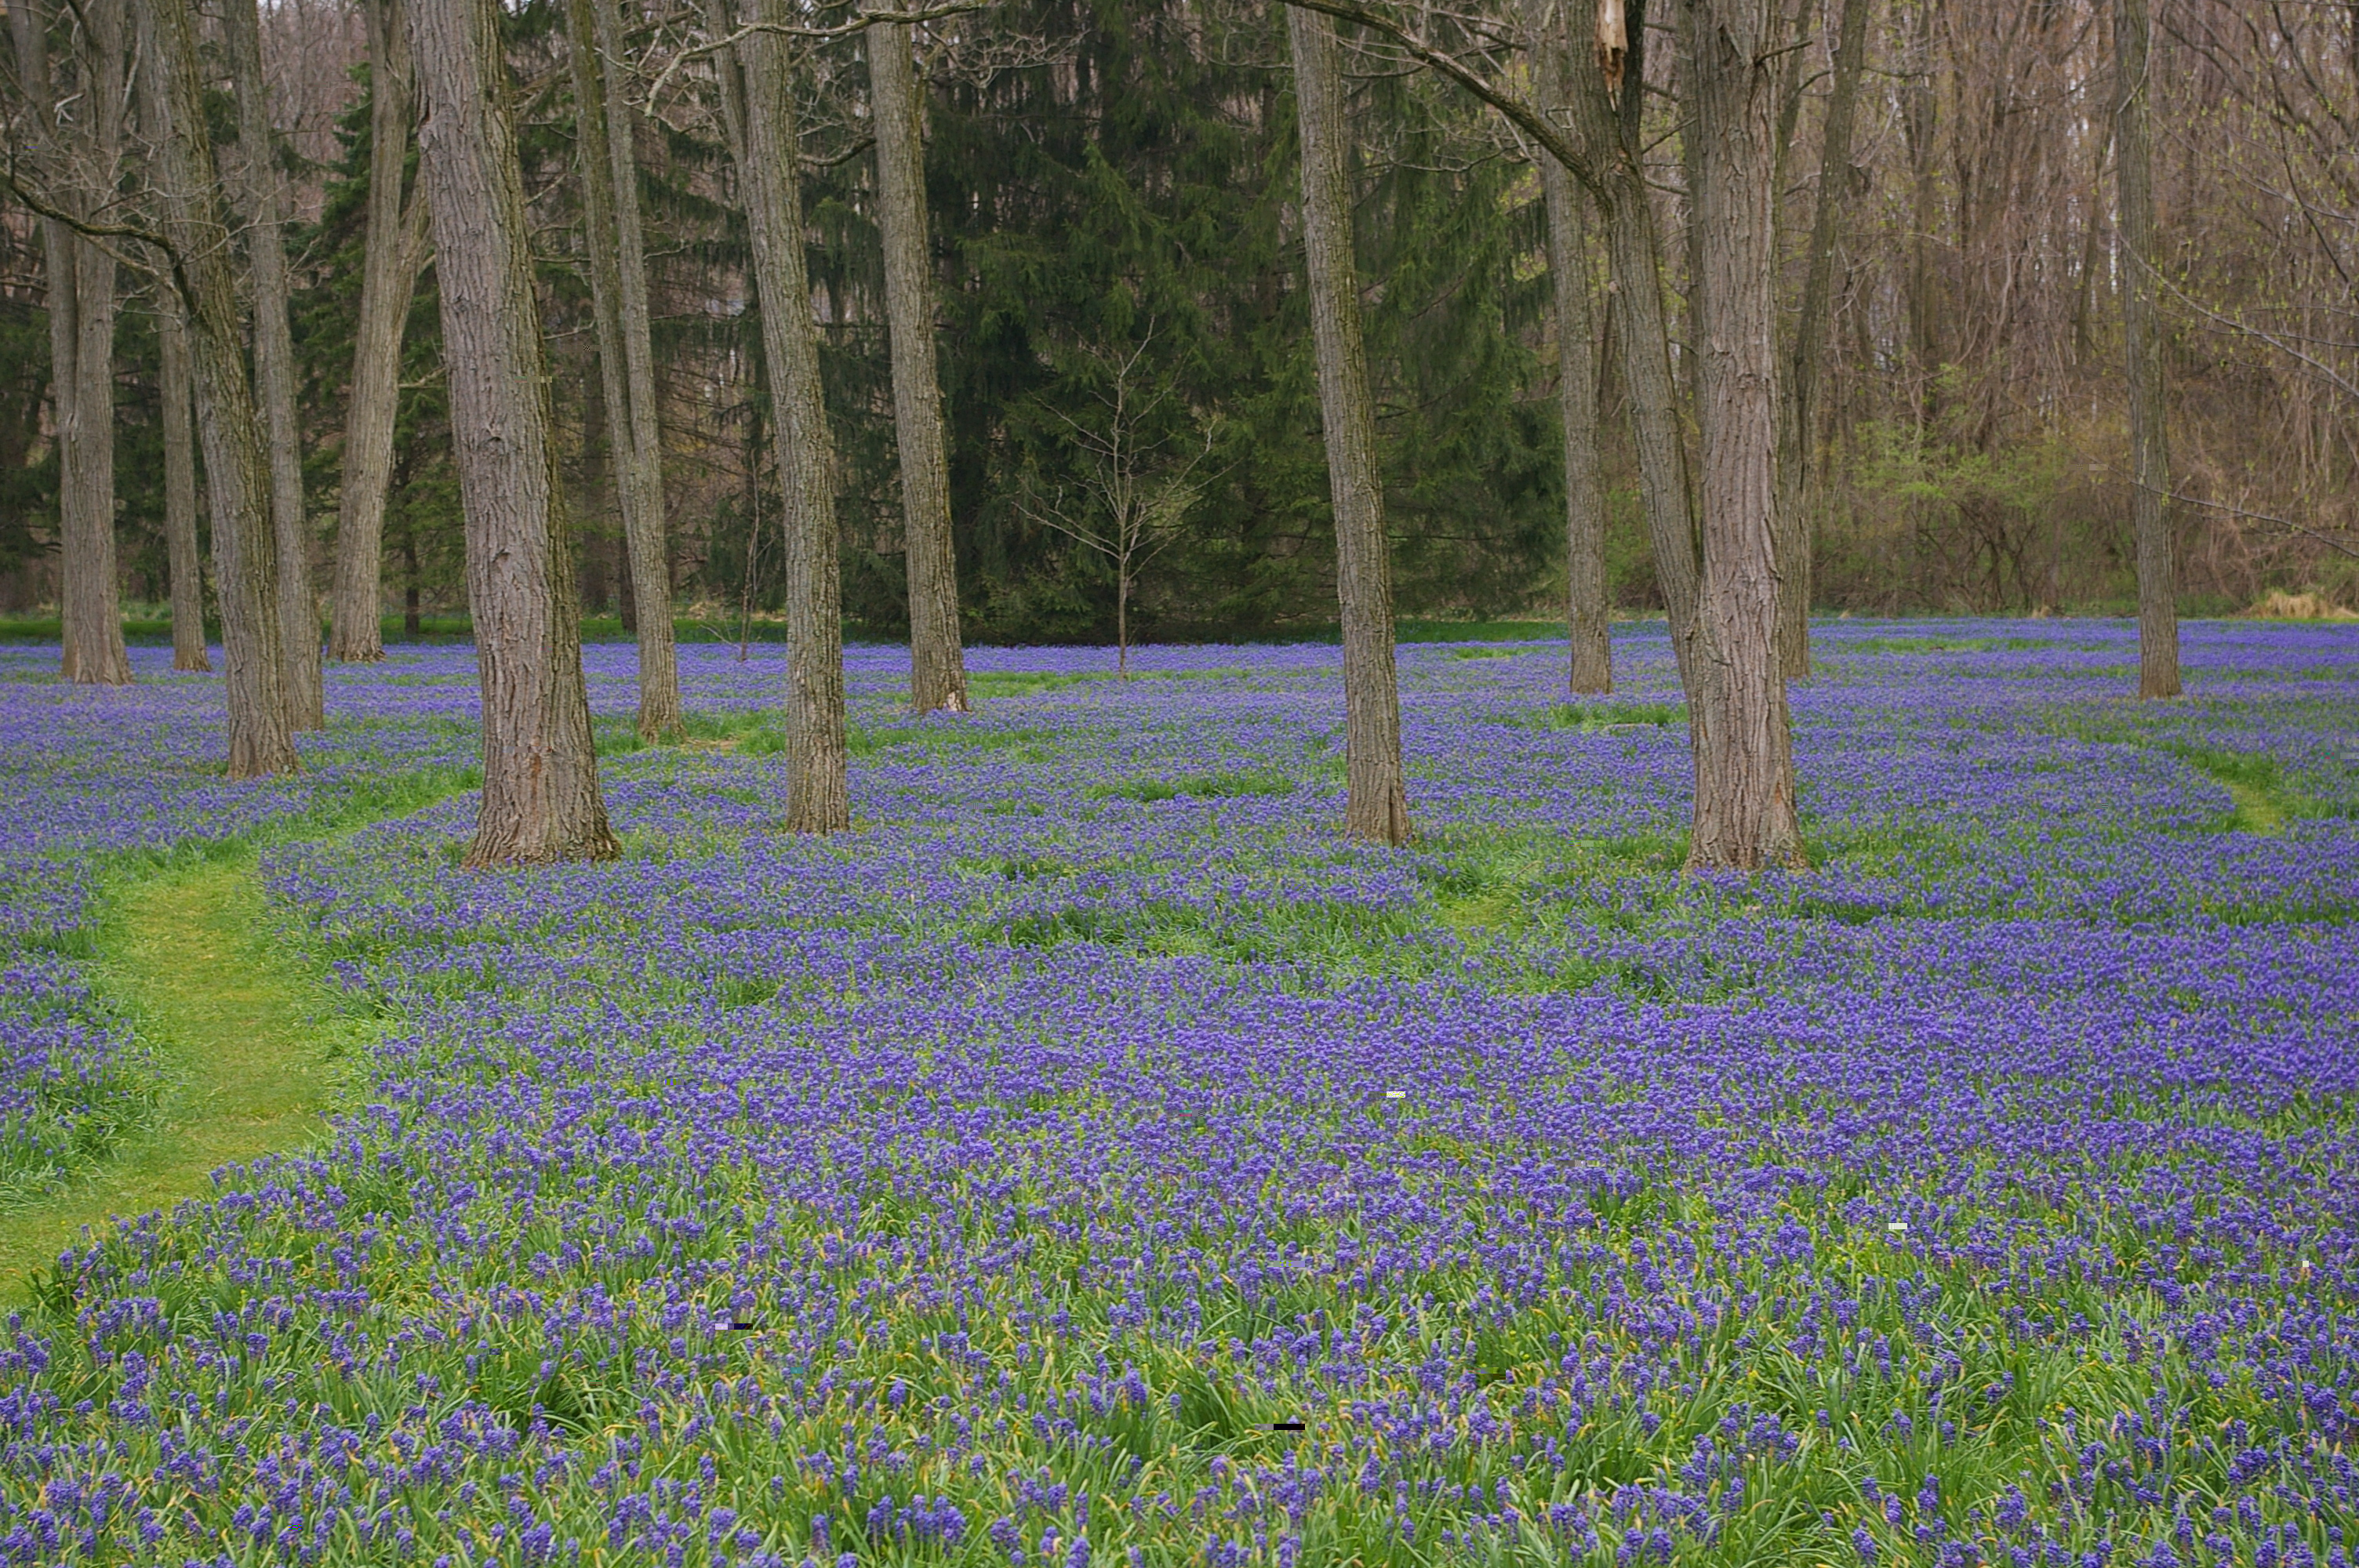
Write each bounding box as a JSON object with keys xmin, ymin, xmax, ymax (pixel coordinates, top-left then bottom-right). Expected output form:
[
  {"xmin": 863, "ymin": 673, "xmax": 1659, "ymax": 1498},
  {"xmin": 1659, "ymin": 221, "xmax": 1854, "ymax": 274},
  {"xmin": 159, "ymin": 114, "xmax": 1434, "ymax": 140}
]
[{"xmin": 1776, "ymin": 0, "xmax": 1870, "ymax": 679}]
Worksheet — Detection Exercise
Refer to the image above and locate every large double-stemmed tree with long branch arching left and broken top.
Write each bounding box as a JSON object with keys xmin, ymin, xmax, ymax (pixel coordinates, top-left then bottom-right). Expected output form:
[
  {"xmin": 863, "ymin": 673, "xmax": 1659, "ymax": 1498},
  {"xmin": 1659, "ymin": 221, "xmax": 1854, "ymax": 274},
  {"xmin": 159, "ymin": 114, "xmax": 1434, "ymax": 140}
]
[{"xmin": 1288, "ymin": 0, "xmax": 1802, "ymax": 870}]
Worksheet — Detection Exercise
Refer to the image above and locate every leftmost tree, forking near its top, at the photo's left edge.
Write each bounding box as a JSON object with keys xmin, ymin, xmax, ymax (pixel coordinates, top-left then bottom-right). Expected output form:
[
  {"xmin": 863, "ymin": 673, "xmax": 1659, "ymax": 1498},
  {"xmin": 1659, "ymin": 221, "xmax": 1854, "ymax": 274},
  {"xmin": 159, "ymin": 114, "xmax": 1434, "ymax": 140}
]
[{"xmin": 9, "ymin": 0, "xmax": 132, "ymax": 686}]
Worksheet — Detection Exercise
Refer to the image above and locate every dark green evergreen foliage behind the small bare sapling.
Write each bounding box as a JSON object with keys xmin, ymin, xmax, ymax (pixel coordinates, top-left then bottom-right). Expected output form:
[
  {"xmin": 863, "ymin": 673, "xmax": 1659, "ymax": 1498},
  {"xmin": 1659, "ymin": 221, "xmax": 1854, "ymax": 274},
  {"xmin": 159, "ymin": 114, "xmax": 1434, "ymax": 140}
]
[{"xmin": 811, "ymin": 0, "xmax": 1561, "ymax": 641}]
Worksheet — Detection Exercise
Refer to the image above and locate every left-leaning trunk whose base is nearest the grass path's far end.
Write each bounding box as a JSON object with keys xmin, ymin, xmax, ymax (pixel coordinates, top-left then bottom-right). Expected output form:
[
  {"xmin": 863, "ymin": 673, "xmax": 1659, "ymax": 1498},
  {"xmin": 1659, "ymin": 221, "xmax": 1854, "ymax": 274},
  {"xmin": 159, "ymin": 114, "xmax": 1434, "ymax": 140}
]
[{"xmin": 139, "ymin": 0, "xmax": 300, "ymax": 778}]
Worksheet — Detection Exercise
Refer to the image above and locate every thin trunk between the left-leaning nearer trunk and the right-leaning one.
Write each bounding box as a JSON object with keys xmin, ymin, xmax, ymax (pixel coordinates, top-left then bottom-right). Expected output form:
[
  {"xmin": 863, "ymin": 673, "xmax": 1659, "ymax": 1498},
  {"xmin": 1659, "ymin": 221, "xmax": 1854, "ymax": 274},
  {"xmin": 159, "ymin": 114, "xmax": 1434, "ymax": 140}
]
[{"xmin": 222, "ymin": 0, "xmax": 328, "ymax": 728}]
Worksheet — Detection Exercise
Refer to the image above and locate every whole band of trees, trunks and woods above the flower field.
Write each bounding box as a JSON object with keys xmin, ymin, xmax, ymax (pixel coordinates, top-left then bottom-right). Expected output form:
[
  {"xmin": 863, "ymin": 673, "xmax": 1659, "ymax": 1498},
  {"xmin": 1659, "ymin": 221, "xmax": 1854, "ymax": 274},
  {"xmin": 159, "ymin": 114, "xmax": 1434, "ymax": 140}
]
[{"xmin": 0, "ymin": 0, "xmax": 2359, "ymax": 866}]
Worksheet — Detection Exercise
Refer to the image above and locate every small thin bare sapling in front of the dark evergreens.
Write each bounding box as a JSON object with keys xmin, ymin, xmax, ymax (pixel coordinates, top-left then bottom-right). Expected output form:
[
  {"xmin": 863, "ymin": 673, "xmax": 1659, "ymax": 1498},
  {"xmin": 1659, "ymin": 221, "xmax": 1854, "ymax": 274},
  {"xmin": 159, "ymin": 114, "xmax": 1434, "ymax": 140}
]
[{"xmin": 1023, "ymin": 321, "xmax": 1212, "ymax": 679}]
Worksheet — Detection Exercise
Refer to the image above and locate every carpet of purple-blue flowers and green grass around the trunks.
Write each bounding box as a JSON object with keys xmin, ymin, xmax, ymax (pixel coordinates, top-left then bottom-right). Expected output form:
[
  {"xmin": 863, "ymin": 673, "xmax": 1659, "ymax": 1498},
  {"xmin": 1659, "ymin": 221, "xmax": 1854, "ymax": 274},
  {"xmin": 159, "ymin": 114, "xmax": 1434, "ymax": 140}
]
[{"xmin": 0, "ymin": 620, "xmax": 2359, "ymax": 1568}]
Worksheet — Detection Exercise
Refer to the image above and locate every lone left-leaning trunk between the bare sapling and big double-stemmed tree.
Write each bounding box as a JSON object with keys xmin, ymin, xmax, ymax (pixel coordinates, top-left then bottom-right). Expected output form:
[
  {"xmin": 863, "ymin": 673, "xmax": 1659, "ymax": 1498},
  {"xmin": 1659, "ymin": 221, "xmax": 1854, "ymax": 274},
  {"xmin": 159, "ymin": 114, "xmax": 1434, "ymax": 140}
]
[{"xmin": 1285, "ymin": 7, "xmax": 1411, "ymax": 844}]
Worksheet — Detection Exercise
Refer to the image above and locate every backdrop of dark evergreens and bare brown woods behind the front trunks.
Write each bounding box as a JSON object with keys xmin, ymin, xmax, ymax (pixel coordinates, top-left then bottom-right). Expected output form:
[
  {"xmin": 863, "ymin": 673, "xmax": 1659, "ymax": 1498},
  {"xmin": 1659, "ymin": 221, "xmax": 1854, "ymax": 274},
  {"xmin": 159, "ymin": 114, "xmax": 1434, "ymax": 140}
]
[{"xmin": 0, "ymin": 0, "xmax": 2359, "ymax": 641}]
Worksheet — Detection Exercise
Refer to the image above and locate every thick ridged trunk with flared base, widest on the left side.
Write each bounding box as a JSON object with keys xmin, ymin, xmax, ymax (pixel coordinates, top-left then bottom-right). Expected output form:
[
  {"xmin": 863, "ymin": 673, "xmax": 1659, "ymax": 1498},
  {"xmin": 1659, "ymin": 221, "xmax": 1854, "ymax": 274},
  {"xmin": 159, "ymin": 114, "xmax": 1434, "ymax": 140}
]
[{"xmin": 408, "ymin": 0, "xmax": 618, "ymax": 866}]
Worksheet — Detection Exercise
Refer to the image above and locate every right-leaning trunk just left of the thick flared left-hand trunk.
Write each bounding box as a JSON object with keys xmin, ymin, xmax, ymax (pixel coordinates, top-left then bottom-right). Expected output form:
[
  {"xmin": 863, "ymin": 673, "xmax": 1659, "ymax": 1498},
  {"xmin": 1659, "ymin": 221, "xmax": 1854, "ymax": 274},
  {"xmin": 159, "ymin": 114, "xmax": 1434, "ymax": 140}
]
[{"xmin": 328, "ymin": 0, "xmax": 427, "ymax": 662}]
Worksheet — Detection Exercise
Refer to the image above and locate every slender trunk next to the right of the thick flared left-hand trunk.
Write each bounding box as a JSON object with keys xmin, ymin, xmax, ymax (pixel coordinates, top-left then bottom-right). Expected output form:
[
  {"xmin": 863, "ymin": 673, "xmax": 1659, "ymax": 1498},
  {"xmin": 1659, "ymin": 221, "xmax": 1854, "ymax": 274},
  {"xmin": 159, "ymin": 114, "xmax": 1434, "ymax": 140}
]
[{"xmin": 566, "ymin": 0, "xmax": 682, "ymax": 742}]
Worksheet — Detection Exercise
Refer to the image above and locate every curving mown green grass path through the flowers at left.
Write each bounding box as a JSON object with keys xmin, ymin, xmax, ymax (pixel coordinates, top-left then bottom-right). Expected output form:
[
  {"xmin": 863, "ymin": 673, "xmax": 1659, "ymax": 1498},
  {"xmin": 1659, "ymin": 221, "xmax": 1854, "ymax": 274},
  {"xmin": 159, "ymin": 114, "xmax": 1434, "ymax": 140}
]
[{"xmin": 0, "ymin": 854, "xmax": 351, "ymax": 1299}]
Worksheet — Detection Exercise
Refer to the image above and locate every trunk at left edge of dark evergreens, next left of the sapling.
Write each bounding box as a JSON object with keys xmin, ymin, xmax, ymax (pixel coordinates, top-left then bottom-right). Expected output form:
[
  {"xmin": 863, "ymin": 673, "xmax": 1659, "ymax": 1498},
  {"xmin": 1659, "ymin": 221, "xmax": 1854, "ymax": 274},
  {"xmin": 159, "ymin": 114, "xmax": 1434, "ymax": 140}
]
[{"xmin": 868, "ymin": 5, "xmax": 967, "ymax": 712}]
